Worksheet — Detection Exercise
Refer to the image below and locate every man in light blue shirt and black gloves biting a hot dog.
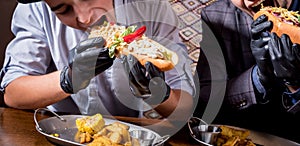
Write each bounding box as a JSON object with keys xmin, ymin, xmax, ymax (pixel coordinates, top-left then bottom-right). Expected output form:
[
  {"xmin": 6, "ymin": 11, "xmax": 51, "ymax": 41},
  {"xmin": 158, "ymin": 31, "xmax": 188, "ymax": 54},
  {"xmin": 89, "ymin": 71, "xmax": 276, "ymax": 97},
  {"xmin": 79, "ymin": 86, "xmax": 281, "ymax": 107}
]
[{"xmin": 1, "ymin": 0, "xmax": 195, "ymax": 132}]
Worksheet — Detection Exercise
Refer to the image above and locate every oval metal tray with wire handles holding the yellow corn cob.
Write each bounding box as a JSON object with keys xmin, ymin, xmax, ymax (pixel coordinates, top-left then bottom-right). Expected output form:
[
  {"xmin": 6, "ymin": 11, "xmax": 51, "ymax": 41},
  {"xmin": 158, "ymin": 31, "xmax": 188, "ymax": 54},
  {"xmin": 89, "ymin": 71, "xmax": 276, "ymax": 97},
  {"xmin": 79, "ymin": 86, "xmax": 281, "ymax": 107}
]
[{"xmin": 34, "ymin": 108, "xmax": 169, "ymax": 146}]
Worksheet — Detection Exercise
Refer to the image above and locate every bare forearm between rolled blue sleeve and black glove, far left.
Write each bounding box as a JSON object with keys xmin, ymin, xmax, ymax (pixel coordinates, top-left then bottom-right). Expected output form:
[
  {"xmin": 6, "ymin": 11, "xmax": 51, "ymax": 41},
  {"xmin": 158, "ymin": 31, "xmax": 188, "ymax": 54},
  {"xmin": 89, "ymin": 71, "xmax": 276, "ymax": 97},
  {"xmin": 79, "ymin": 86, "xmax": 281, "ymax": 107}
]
[{"xmin": 4, "ymin": 71, "xmax": 69, "ymax": 109}]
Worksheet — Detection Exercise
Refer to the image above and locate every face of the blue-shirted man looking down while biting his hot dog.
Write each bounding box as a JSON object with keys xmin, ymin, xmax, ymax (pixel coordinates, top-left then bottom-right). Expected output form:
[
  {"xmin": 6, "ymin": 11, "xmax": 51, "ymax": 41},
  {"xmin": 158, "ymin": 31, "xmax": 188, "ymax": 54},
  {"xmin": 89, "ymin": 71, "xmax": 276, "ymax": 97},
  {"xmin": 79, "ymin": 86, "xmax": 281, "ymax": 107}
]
[{"xmin": 44, "ymin": 0, "xmax": 114, "ymax": 30}]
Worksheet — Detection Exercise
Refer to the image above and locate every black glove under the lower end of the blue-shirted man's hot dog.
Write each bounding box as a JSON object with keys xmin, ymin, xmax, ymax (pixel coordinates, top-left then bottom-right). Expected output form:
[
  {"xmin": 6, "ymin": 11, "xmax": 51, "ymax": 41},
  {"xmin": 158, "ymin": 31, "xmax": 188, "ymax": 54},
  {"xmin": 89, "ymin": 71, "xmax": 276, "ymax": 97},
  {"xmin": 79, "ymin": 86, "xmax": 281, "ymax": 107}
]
[{"xmin": 121, "ymin": 55, "xmax": 170, "ymax": 104}]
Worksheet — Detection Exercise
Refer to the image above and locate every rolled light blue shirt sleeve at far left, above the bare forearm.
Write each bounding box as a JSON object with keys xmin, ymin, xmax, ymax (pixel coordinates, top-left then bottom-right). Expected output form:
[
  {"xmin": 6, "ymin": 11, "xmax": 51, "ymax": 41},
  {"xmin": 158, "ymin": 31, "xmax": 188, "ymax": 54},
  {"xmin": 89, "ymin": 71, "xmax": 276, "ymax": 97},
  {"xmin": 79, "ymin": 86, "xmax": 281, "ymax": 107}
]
[{"xmin": 0, "ymin": 2, "xmax": 51, "ymax": 91}]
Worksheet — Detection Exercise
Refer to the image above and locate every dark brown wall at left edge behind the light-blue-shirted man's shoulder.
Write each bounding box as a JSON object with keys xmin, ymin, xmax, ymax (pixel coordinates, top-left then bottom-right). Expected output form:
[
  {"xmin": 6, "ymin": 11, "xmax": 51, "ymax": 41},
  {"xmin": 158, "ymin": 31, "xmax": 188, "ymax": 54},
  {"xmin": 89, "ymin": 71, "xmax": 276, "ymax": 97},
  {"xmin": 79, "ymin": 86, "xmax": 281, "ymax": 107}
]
[{"xmin": 0, "ymin": 0, "xmax": 17, "ymax": 107}]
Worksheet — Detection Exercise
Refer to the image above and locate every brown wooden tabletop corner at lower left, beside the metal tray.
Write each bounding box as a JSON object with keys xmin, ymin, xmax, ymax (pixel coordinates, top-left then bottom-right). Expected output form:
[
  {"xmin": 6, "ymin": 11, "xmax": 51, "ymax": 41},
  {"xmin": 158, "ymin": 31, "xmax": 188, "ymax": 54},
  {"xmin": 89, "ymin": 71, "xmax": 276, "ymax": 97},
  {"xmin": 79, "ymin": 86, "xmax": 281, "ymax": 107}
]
[{"xmin": 0, "ymin": 108, "xmax": 51, "ymax": 146}]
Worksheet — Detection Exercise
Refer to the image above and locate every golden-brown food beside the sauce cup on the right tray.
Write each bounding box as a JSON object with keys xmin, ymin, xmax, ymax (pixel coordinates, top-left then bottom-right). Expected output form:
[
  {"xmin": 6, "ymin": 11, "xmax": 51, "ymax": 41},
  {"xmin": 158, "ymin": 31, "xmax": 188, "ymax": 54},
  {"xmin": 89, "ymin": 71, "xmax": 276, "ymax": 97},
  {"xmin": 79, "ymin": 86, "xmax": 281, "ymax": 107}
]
[{"xmin": 216, "ymin": 125, "xmax": 255, "ymax": 146}]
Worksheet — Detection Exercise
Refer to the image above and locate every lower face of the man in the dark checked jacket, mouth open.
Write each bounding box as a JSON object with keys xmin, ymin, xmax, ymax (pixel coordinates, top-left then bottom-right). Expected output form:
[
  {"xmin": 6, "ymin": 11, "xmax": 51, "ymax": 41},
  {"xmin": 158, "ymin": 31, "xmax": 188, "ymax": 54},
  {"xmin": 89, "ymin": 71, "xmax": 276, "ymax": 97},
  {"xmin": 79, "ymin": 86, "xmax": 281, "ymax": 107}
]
[{"xmin": 231, "ymin": 0, "xmax": 292, "ymax": 16}]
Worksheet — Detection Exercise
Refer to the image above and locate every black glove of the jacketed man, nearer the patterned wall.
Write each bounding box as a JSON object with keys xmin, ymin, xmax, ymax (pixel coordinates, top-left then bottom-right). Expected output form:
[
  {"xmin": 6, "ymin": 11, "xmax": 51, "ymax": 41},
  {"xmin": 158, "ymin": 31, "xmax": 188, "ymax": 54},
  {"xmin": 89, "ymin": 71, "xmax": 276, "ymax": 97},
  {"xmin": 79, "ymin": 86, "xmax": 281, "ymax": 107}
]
[{"xmin": 251, "ymin": 15, "xmax": 275, "ymax": 88}]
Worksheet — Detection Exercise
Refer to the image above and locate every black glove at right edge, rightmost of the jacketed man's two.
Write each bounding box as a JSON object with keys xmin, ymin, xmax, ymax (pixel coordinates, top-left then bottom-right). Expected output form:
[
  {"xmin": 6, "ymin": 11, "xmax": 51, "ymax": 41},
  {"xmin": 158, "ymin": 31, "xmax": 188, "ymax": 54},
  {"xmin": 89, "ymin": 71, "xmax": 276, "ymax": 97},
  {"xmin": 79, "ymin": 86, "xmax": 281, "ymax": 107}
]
[{"xmin": 269, "ymin": 33, "xmax": 300, "ymax": 86}]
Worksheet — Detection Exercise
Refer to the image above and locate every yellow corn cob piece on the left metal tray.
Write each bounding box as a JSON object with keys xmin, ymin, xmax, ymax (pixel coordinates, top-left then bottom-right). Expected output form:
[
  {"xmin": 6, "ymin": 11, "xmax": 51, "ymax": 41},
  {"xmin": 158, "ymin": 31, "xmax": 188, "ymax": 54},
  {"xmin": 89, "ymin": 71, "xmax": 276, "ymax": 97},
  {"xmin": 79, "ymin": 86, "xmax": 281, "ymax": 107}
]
[{"xmin": 76, "ymin": 114, "xmax": 105, "ymax": 135}]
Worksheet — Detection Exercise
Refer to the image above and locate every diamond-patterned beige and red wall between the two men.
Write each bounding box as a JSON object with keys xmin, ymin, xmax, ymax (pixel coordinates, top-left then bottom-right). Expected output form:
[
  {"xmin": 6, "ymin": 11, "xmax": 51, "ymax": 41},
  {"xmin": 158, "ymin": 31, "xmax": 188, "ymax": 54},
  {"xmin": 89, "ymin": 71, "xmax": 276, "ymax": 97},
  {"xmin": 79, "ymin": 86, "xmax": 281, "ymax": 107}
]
[{"xmin": 169, "ymin": 0, "xmax": 216, "ymax": 71}]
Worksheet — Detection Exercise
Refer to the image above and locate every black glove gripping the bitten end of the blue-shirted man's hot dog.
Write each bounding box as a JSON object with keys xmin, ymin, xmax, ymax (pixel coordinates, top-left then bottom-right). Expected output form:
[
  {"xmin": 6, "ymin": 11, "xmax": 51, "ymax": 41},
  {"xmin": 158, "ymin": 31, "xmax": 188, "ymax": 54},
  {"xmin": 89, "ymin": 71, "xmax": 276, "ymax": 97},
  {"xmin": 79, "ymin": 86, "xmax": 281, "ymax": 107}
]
[{"xmin": 60, "ymin": 37, "xmax": 115, "ymax": 94}]
